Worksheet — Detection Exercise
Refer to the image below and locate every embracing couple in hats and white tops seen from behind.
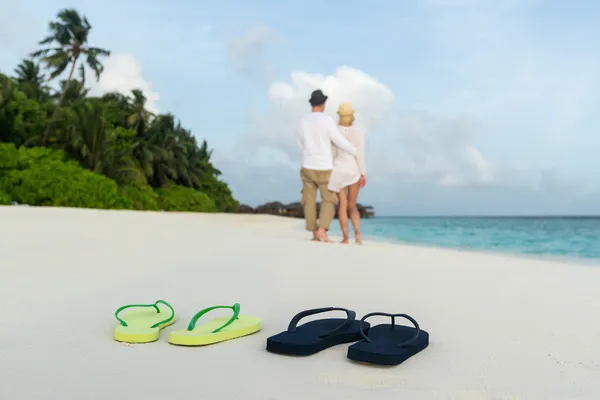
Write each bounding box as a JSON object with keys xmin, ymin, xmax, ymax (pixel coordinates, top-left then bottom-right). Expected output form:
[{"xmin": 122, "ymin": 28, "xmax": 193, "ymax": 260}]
[{"xmin": 297, "ymin": 90, "xmax": 367, "ymax": 244}]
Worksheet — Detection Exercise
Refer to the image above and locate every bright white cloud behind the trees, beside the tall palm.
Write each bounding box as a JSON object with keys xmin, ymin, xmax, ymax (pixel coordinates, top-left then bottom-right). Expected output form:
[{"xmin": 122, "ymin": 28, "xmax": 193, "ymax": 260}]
[{"xmin": 86, "ymin": 53, "xmax": 159, "ymax": 113}]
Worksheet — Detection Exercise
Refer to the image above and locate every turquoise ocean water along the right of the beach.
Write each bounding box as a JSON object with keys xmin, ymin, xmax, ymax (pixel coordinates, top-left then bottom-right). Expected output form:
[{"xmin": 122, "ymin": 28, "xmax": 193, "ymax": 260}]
[{"xmin": 331, "ymin": 217, "xmax": 600, "ymax": 261}]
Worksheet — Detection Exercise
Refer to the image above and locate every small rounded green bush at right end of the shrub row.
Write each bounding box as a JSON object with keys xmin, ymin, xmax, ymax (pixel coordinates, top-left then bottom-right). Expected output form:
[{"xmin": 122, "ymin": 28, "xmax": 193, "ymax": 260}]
[{"xmin": 156, "ymin": 186, "xmax": 217, "ymax": 212}]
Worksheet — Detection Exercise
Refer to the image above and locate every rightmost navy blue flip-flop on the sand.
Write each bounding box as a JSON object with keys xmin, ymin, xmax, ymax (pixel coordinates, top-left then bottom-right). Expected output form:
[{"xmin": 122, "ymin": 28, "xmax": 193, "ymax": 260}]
[{"xmin": 348, "ymin": 312, "xmax": 429, "ymax": 365}]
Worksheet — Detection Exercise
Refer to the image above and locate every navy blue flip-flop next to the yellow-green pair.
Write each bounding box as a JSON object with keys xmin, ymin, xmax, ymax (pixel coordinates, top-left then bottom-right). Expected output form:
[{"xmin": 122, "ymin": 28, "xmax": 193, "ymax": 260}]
[{"xmin": 267, "ymin": 307, "xmax": 370, "ymax": 356}]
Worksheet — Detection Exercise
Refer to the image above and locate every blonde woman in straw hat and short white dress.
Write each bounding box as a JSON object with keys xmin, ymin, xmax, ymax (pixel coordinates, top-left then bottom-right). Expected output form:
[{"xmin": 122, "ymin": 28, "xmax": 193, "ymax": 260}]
[{"xmin": 328, "ymin": 103, "xmax": 367, "ymax": 244}]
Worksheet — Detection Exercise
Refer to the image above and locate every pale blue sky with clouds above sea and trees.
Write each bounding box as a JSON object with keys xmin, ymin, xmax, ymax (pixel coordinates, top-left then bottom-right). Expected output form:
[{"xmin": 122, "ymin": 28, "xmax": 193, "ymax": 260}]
[{"xmin": 0, "ymin": 0, "xmax": 600, "ymax": 214}]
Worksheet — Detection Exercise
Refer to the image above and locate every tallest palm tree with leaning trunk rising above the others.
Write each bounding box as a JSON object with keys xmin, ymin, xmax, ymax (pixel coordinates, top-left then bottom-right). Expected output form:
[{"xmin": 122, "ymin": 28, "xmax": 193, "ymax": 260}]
[{"xmin": 31, "ymin": 9, "xmax": 110, "ymax": 146}]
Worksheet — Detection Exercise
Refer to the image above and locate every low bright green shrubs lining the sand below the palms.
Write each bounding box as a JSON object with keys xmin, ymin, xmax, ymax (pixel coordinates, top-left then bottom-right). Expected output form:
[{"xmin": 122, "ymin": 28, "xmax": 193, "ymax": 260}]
[{"xmin": 0, "ymin": 143, "xmax": 227, "ymax": 212}]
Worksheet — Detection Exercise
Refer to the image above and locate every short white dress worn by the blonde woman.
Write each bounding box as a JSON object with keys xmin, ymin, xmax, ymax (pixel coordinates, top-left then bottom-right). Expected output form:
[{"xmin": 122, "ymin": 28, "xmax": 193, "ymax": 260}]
[{"xmin": 328, "ymin": 126, "xmax": 366, "ymax": 193}]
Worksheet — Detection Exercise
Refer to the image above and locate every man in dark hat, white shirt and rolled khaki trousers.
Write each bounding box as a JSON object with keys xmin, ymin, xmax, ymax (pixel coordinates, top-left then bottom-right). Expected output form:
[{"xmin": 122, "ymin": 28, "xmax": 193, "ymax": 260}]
[{"xmin": 297, "ymin": 90, "xmax": 357, "ymax": 243}]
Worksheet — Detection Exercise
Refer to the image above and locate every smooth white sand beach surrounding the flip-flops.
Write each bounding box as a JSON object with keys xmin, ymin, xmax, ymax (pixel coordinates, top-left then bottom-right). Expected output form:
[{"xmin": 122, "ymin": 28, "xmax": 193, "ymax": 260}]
[{"xmin": 0, "ymin": 207, "xmax": 600, "ymax": 400}]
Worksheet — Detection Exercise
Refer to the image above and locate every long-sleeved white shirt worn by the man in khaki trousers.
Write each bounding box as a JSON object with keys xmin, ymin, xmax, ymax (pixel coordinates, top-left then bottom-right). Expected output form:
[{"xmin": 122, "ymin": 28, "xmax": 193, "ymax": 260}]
[{"xmin": 297, "ymin": 112, "xmax": 358, "ymax": 170}]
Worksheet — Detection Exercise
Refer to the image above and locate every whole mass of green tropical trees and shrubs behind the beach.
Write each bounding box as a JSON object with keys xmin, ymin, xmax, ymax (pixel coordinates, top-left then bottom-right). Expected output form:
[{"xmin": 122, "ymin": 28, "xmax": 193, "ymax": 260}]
[{"xmin": 0, "ymin": 9, "xmax": 239, "ymax": 212}]
